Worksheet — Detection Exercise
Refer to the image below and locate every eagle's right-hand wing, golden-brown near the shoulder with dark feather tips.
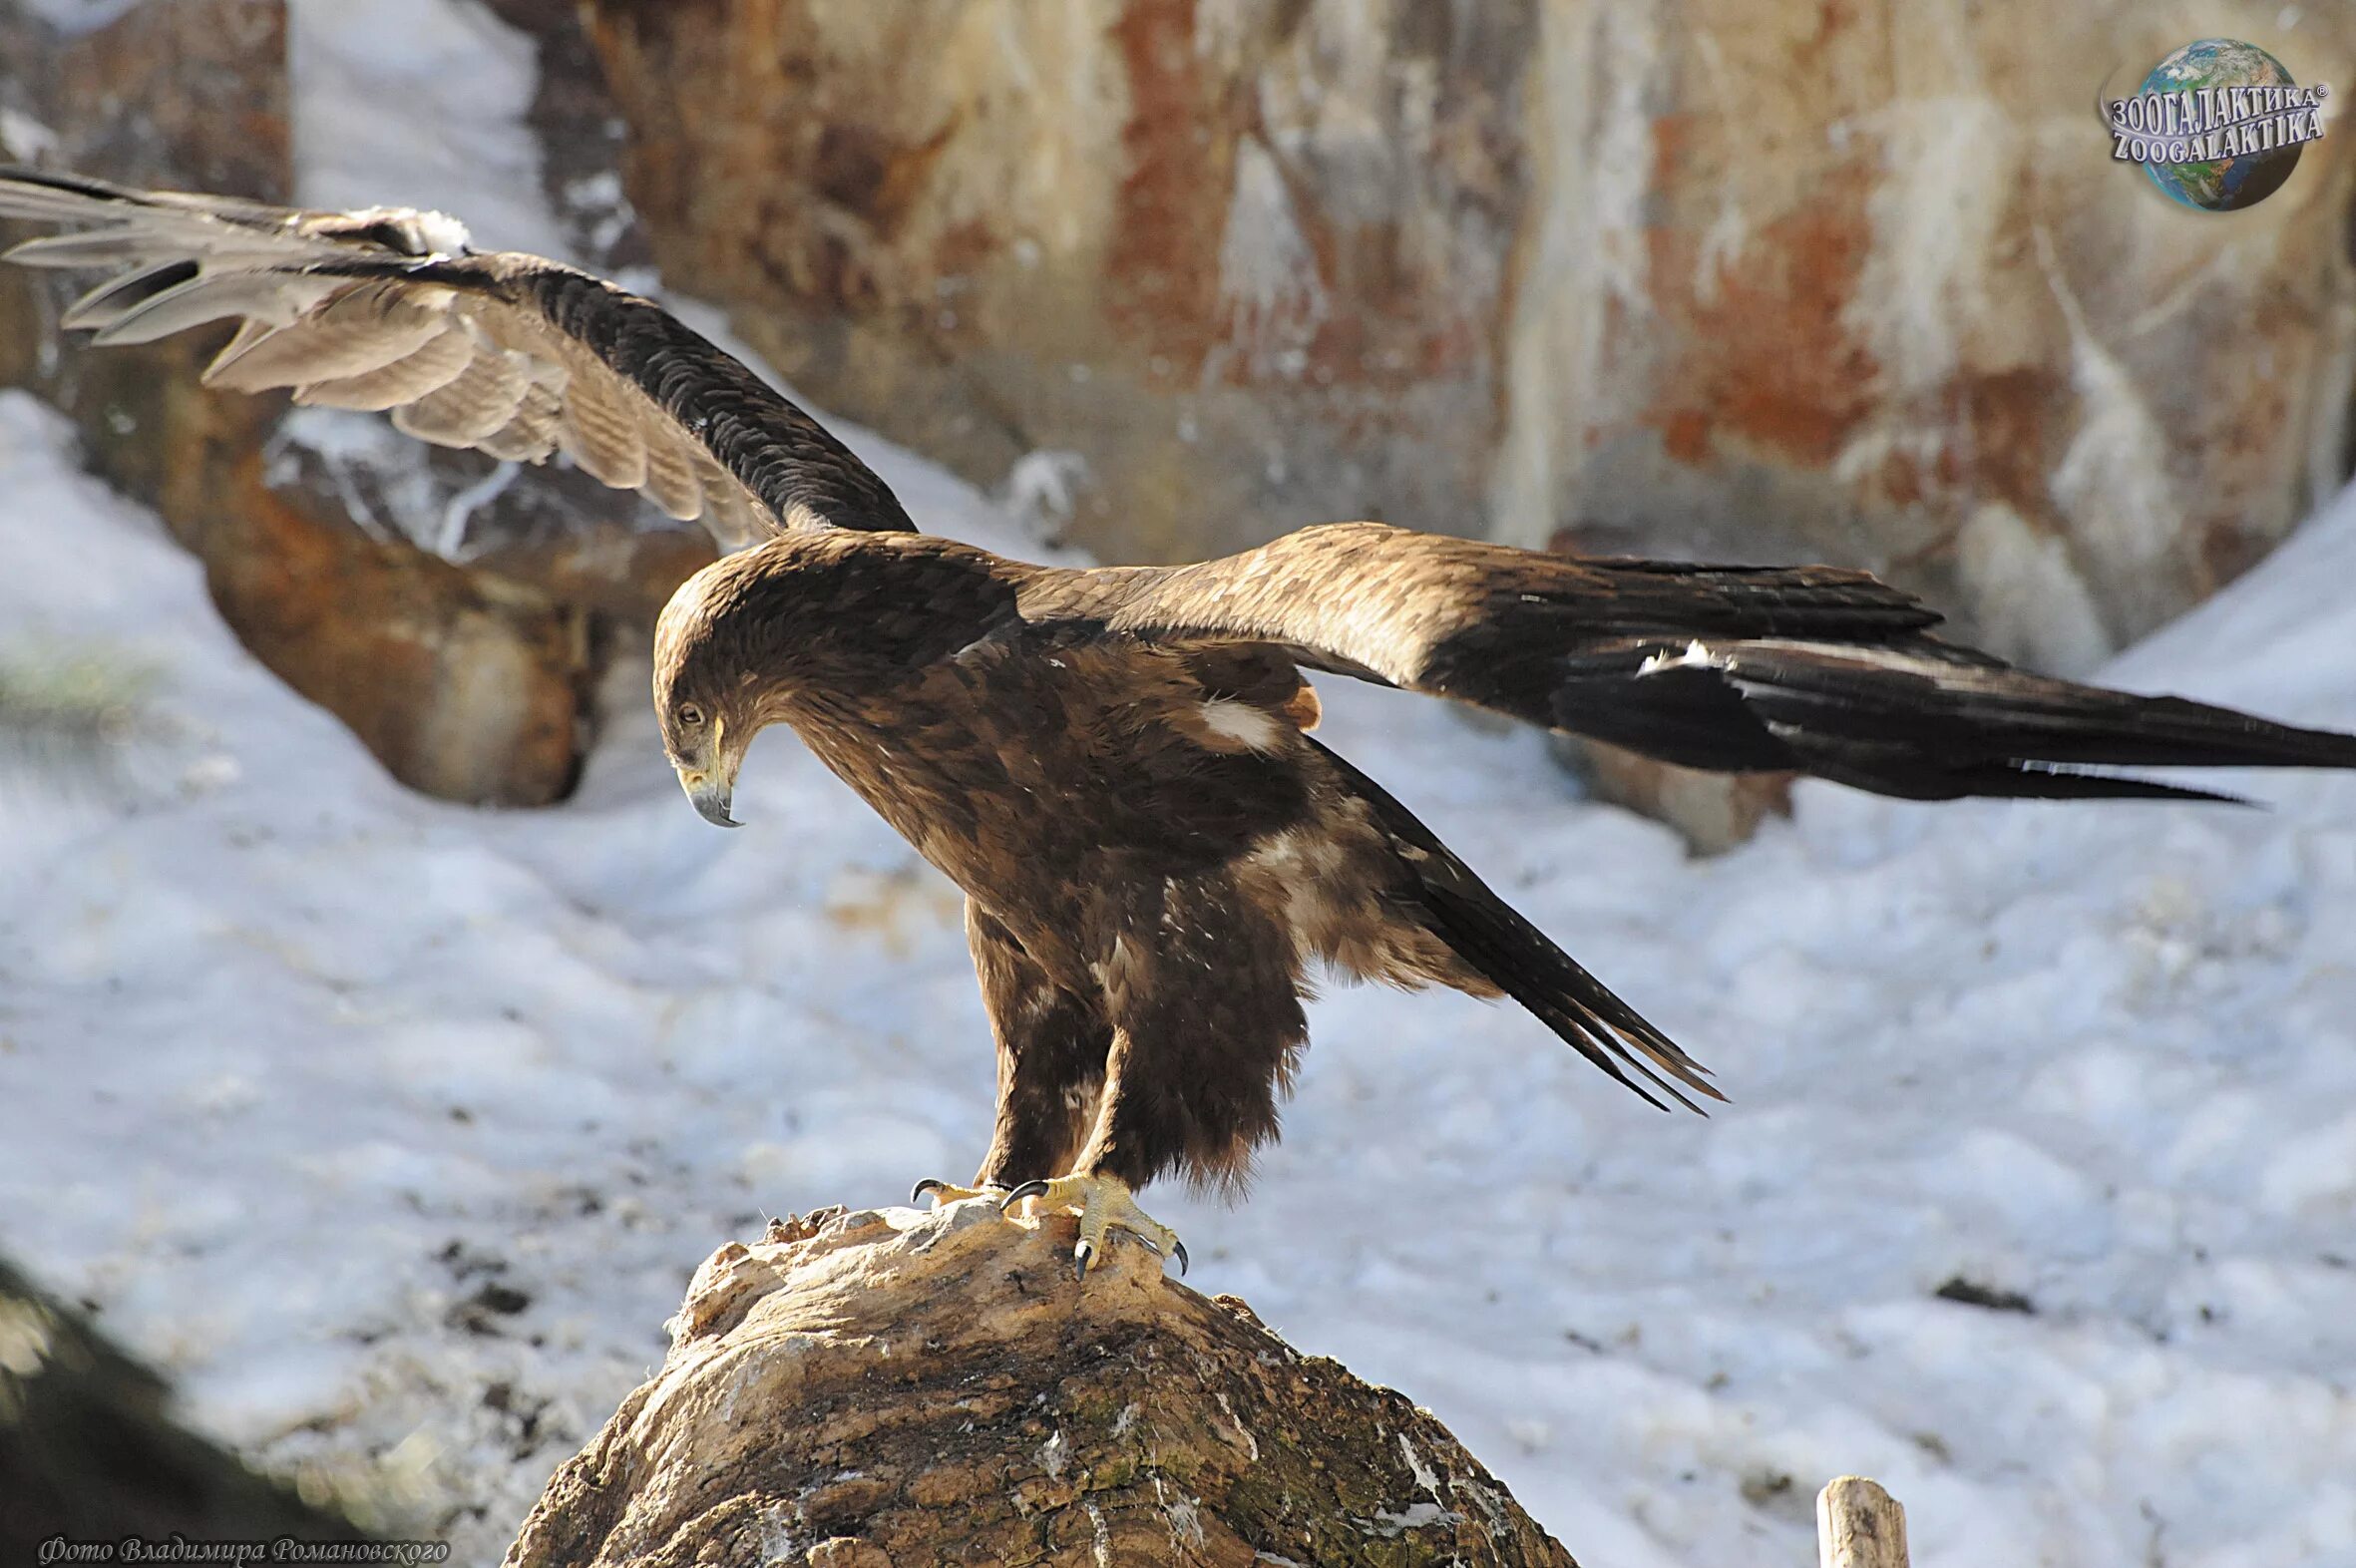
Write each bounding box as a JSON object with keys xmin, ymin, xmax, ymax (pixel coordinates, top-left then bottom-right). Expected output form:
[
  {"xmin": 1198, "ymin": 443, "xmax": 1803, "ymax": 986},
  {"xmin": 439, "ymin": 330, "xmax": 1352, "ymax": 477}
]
[{"xmin": 1020, "ymin": 523, "xmax": 2356, "ymax": 801}]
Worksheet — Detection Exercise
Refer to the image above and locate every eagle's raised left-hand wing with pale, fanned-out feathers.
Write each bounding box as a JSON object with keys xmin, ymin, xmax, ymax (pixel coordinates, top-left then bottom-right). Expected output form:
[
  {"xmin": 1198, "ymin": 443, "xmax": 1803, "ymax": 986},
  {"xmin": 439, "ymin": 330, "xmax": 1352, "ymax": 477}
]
[{"xmin": 0, "ymin": 170, "xmax": 912, "ymax": 547}]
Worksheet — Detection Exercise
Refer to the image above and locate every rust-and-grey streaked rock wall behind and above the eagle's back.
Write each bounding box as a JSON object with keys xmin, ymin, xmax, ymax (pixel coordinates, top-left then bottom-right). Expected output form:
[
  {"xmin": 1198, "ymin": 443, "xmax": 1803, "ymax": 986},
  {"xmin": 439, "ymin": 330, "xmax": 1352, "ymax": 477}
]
[{"xmin": 585, "ymin": 0, "xmax": 2356, "ymax": 671}]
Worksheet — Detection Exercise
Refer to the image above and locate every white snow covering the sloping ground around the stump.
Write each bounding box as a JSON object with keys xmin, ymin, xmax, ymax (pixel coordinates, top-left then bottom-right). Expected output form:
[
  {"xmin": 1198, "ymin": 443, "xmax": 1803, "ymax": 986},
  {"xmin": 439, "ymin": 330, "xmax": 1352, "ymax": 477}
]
[{"xmin": 0, "ymin": 5, "xmax": 2356, "ymax": 1568}]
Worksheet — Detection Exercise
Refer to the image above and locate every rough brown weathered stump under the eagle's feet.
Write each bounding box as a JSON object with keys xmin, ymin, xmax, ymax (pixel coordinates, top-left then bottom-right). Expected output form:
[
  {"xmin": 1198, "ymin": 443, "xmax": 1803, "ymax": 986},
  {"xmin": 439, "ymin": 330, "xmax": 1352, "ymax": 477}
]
[{"xmin": 507, "ymin": 1201, "xmax": 1576, "ymax": 1568}]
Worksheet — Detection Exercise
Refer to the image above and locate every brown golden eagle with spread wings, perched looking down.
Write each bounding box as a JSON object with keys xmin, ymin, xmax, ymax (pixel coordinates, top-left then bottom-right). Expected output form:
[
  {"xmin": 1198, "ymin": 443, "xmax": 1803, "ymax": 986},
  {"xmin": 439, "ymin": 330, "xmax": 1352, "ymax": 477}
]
[{"xmin": 0, "ymin": 172, "xmax": 2356, "ymax": 1272}]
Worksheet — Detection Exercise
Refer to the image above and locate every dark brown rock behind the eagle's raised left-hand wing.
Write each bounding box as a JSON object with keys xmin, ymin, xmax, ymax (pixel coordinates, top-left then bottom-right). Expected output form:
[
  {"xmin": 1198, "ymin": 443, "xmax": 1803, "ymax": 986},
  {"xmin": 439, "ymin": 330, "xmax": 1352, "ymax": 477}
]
[{"xmin": 0, "ymin": 0, "xmax": 709, "ymax": 805}]
